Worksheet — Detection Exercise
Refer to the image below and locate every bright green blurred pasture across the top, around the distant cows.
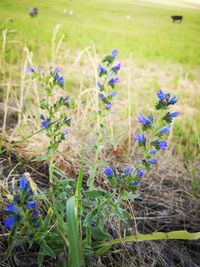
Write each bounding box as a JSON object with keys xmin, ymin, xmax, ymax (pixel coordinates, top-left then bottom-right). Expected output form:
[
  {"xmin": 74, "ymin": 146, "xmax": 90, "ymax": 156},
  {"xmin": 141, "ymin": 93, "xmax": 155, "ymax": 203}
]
[{"xmin": 0, "ymin": 0, "xmax": 200, "ymax": 66}]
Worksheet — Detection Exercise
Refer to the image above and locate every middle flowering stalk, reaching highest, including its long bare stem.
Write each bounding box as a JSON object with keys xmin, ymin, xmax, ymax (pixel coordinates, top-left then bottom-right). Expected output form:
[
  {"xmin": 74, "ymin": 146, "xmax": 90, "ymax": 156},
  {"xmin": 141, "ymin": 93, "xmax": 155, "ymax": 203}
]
[{"xmin": 88, "ymin": 49, "xmax": 121, "ymax": 186}]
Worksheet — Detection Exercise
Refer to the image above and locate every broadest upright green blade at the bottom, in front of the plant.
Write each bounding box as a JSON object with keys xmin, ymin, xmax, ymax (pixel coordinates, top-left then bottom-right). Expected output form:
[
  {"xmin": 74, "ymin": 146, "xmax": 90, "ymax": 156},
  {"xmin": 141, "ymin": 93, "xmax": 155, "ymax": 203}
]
[{"xmin": 66, "ymin": 197, "xmax": 82, "ymax": 267}]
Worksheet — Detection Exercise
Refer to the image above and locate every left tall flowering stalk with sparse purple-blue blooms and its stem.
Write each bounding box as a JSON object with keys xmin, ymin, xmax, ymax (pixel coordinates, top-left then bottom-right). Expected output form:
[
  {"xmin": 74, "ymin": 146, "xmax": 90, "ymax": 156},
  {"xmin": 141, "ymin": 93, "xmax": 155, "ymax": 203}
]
[{"xmin": 28, "ymin": 67, "xmax": 71, "ymax": 184}]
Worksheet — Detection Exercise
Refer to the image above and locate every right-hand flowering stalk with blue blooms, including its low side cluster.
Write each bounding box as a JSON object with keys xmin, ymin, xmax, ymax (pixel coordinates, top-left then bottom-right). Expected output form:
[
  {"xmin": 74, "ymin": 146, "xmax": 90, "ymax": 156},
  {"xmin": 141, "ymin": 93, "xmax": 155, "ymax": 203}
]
[{"xmin": 104, "ymin": 90, "xmax": 179, "ymax": 196}]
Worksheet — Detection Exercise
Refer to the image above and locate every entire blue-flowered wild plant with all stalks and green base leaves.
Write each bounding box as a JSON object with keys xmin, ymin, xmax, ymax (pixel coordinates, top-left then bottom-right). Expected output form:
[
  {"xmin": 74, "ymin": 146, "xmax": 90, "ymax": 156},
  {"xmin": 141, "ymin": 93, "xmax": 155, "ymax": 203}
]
[{"xmin": 3, "ymin": 49, "xmax": 199, "ymax": 267}]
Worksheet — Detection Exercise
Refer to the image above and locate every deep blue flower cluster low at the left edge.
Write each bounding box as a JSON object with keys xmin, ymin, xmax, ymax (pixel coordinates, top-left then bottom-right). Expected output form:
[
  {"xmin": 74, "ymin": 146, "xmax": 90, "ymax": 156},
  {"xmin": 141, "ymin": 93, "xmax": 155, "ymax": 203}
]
[{"xmin": 3, "ymin": 176, "xmax": 41, "ymax": 233}]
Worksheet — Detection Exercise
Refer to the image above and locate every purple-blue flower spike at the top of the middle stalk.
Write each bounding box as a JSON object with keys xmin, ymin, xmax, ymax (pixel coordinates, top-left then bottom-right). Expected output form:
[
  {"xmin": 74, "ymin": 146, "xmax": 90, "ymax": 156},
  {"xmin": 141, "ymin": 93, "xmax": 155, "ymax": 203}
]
[{"xmin": 97, "ymin": 49, "xmax": 121, "ymax": 110}]
